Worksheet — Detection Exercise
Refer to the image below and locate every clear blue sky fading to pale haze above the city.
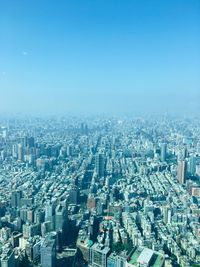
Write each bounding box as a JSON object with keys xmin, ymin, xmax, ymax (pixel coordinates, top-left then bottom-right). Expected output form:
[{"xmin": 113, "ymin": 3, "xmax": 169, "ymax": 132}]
[{"xmin": 0, "ymin": 0, "xmax": 200, "ymax": 114}]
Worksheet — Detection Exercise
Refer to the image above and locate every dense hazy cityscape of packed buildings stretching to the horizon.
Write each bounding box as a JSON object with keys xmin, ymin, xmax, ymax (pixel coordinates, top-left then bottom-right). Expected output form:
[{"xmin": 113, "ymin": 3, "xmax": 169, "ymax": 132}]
[{"xmin": 0, "ymin": 115, "xmax": 200, "ymax": 267}]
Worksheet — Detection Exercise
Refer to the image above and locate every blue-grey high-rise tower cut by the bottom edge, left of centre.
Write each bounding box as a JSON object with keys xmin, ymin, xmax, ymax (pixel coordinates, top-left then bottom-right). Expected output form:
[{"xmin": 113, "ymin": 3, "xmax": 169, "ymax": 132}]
[{"xmin": 41, "ymin": 235, "xmax": 56, "ymax": 267}]
